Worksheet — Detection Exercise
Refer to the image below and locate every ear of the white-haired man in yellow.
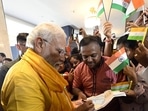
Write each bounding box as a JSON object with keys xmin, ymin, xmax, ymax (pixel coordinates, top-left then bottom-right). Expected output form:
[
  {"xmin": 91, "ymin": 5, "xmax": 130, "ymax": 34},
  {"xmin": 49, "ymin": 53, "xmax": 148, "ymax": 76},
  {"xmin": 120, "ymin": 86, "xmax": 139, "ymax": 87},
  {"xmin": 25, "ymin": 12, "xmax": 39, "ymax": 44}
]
[{"xmin": 34, "ymin": 37, "xmax": 44, "ymax": 53}]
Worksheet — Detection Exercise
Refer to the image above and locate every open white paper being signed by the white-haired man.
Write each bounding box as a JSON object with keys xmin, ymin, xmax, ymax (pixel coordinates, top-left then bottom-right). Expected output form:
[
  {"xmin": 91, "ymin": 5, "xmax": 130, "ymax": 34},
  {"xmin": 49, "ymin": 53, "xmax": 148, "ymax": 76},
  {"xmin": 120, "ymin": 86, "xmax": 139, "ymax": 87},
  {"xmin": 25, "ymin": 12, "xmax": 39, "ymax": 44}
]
[{"xmin": 87, "ymin": 90, "xmax": 126, "ymax": 110}]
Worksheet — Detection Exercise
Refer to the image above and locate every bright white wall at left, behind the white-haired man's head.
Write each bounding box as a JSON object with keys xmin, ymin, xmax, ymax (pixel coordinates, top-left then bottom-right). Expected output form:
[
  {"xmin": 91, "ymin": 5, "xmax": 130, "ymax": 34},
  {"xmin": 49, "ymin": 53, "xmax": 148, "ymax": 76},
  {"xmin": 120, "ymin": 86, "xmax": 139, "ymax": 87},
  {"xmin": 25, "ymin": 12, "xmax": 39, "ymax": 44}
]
[{"xmin": 5, "ymin": 15, "xmax": 35, "ymax": 59}]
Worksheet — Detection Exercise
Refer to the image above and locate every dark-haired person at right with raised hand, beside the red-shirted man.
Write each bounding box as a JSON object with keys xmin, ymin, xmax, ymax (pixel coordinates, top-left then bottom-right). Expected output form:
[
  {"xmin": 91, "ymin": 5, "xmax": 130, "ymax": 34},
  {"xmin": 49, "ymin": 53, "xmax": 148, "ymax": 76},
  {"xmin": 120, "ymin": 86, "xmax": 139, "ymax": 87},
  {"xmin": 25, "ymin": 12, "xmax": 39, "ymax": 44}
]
[{"xmin": 117, "ymin": 34, "xmax": 148, "ymax": 111}]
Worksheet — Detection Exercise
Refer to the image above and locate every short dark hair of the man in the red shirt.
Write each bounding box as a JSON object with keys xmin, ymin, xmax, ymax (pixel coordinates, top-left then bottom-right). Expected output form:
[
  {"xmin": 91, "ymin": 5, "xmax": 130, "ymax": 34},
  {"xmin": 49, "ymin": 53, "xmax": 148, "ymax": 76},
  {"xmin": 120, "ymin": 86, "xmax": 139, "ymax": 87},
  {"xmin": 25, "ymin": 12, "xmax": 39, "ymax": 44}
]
[{"xmin": 79, "ymin": 35, "xmax": 103, "ymax": 48}]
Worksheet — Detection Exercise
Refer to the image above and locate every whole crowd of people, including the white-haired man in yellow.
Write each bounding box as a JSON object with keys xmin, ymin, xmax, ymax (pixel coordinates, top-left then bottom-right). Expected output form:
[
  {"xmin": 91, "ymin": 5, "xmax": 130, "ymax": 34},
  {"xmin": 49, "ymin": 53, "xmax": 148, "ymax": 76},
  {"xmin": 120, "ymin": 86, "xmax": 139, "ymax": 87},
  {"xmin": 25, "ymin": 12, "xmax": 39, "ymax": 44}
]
[{"xmin": 0, "ymin": 6, "xmax": 148, "ymax": 111}]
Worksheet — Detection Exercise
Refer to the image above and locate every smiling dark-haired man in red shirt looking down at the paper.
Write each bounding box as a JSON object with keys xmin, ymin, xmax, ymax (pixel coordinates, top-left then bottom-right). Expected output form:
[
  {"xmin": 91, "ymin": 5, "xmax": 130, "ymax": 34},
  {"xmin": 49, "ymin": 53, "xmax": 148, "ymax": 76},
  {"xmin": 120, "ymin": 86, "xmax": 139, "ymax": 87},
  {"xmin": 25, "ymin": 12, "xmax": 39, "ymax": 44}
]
[{"xmin": 73, "ymin": 36, "xmax": 125, "ymax": 111}]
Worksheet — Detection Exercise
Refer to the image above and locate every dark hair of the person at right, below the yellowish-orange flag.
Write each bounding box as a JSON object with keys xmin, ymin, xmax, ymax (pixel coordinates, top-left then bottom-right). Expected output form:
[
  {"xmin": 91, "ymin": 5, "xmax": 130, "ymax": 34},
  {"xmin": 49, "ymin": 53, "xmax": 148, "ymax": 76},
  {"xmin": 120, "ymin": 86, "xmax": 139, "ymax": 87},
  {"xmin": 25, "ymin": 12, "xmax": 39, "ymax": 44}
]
[{"xmin": 117, "ymin": 34, "xmax": 138, "ymax": 49}]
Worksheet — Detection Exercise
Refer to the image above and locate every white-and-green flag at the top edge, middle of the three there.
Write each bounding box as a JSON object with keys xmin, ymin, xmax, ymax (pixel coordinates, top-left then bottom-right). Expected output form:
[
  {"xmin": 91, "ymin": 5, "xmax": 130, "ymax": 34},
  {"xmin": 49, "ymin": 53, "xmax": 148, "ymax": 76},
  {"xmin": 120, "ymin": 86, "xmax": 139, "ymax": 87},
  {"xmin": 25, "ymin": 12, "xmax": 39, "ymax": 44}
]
[{"xmin": 111, "ymin": 0, "xmax": 131, "ymax": 13}]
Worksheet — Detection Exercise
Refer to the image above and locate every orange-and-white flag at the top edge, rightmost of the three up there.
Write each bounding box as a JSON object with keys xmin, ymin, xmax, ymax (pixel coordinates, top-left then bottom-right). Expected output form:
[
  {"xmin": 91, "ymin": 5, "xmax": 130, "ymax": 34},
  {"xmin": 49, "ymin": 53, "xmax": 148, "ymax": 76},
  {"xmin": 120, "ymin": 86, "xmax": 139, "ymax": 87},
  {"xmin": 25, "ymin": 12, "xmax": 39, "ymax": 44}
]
[{"xmin": 126, "ymin": 0, "xmax": 144, "ymax": 16}]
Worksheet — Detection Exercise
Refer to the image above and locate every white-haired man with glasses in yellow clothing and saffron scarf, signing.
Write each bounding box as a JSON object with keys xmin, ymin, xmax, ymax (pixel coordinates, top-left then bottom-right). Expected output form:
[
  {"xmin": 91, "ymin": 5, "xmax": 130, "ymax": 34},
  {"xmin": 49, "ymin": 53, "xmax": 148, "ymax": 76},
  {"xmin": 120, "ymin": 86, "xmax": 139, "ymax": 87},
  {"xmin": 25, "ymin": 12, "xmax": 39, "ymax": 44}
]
[{"xmin": 1, "ymin": 23, "xmax": 94, "ymax": 111}]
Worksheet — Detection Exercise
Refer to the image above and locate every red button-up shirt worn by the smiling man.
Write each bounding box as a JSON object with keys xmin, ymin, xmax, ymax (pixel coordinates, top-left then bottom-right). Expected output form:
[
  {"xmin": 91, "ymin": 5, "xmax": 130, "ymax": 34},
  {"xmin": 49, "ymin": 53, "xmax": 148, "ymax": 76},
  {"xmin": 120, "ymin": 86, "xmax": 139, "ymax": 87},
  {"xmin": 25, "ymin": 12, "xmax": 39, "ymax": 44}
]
[{"xmin": 73, "ymin": 57, "xmax": 125, "ymax": 111}]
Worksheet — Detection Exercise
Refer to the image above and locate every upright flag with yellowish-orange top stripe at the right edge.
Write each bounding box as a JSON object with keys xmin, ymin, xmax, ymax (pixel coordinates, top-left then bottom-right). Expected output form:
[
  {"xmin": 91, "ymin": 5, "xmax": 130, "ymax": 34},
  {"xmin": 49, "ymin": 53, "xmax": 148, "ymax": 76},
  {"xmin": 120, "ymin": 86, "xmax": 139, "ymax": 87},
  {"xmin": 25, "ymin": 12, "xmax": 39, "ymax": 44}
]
[{"xmin": 127, "ymin": 27, "xmax": 148, "ymax": 42}]
